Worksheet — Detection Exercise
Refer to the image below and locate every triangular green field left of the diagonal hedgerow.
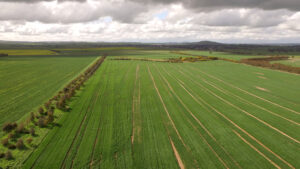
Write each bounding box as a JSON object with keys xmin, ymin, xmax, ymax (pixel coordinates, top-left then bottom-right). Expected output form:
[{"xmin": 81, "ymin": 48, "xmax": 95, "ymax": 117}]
[{"xmin": 0, "ymin": 56, "xmax": 95, "ymax": 126}]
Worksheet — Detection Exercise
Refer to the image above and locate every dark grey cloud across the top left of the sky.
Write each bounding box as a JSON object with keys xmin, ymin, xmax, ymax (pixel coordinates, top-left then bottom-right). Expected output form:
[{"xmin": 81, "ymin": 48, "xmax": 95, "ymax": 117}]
[{"xmin": 0, "ymin": 1, "xmax": 147, "ymax": 24}]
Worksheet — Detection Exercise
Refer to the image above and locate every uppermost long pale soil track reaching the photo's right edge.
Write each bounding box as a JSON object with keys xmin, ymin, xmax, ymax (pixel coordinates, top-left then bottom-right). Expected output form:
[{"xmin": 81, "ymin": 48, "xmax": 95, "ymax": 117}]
[{"xmin": 195, "ymin": 69, "xmax": 300, "ymax": 114}]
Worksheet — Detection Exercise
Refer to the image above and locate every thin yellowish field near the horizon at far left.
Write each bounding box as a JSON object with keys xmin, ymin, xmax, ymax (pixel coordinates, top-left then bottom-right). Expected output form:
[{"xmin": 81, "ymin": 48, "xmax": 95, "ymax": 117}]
[{"xmin": 0, "ymin": 49, "xmax": 56, "ymax": 56}]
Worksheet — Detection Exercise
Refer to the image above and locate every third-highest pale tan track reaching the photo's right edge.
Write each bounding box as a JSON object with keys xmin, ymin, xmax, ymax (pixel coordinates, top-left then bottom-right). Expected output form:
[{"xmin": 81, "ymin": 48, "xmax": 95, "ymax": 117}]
[{"xmin": 179, "ymin": 67, "xmax": 300, "ymax": 144}]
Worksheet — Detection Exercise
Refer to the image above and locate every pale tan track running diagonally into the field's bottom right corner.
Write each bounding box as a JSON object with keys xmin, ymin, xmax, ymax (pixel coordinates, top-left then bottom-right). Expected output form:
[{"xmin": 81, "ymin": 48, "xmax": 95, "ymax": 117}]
[{"xmin": 166, "ymin": 64, "xmax": 295, "ymax": 169}]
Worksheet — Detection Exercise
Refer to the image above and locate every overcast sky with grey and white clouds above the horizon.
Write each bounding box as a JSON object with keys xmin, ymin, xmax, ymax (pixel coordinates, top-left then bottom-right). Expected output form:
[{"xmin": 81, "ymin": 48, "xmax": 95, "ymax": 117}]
[{"xmin": 0, "ymin": 0, "xmax": 300, "ymax": 43}]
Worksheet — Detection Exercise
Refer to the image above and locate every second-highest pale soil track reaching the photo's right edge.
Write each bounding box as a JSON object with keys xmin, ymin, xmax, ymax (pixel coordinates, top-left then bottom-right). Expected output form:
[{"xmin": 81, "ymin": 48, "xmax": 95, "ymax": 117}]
[{"xmin": 197, "ymin": 78, "xmax": 300, "ymax": 126}]
